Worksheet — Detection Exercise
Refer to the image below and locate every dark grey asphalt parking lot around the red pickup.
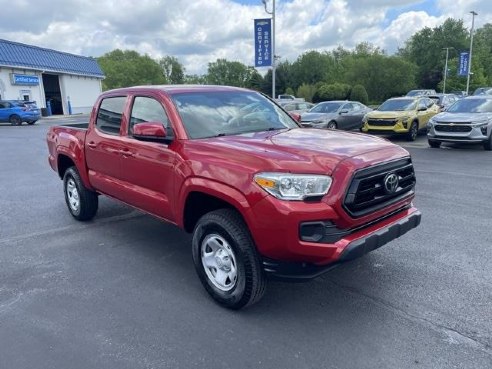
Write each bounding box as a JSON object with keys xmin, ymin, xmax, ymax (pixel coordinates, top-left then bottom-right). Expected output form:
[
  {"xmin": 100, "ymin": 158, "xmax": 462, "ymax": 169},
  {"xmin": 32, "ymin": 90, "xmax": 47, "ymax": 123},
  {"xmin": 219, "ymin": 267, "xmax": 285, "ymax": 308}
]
[{"xmin": 0, "ymin": 117, "xmax": 492, "ymax": 369}]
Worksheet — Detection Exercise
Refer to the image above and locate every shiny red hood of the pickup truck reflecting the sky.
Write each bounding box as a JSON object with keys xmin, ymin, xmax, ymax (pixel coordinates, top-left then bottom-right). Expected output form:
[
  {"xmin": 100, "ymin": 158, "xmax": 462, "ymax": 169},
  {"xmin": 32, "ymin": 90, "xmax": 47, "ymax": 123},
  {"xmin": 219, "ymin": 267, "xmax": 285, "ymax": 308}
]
[{"xmin": 185, "ymin": 128, "xmax": 408, "ymax": 174}]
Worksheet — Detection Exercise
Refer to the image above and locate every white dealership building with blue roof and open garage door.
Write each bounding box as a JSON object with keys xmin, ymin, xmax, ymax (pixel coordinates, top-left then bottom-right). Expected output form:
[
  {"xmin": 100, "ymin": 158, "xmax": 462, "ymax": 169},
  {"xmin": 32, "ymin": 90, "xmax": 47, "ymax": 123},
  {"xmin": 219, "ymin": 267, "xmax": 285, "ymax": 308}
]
[{"xmin": 0, "ymin": 39, "xmax": 104, "ymax": 115}]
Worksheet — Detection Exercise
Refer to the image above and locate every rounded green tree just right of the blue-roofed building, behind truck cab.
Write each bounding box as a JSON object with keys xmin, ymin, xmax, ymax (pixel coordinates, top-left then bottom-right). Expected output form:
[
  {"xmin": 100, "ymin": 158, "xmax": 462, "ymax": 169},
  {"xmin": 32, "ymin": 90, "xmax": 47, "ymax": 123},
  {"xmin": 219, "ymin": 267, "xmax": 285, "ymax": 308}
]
[{"xmin": 97, "ymin": 49, "xmax": 167, "ymax": 90}]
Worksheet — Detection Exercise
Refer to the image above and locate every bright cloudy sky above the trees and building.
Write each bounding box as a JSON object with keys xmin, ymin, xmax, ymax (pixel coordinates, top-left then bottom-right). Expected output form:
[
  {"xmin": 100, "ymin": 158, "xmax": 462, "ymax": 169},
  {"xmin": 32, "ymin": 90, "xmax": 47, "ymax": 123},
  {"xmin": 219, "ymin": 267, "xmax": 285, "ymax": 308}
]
[{"xmin": 0, "ymin": 0, "xmax": 492, "ymax": 74}]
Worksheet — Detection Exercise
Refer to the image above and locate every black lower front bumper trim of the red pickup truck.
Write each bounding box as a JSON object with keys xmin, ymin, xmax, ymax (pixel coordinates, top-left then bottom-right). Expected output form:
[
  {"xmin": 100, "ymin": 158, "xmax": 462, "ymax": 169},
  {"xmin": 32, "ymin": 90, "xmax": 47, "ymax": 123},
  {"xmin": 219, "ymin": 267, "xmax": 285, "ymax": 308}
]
[{"xmin": 263, "ymin": 209, "xmax": 422, "ymax": 282}]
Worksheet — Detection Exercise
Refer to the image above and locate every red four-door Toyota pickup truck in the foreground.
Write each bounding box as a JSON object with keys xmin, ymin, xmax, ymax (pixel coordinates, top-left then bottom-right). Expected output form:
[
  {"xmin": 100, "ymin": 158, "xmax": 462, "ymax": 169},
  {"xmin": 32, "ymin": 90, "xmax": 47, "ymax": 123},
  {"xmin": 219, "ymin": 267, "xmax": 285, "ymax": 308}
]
[{"xmin": 47, "ymin": 86, "xmax": 421, "ymax": 309}]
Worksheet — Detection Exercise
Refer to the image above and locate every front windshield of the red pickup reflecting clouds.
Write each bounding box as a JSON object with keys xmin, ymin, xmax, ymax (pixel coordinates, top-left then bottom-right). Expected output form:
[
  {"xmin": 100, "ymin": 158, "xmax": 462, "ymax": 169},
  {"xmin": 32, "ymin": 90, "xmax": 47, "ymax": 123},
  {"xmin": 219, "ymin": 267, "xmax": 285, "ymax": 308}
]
[{"xmin": 172, "ymin": 91, "xmax": 299, "ymax": 138}]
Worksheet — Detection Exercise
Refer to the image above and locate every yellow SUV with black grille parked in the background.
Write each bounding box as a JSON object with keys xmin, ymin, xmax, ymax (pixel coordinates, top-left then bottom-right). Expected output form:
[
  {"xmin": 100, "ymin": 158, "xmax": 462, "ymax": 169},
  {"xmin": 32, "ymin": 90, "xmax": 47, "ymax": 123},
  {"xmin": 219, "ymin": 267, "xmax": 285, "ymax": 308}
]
[{"xmin": 361, "ymin": 96, "xmax": 439, "ymax": 141}]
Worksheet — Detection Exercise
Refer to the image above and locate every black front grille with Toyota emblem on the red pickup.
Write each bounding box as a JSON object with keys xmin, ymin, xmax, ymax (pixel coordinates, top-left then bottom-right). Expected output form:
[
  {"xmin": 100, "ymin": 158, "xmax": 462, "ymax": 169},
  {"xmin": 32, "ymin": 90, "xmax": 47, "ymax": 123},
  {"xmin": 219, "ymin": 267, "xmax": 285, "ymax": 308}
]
[{"xmin": 343, "ymin": 158, "xmax": 416, "ymax": 218}]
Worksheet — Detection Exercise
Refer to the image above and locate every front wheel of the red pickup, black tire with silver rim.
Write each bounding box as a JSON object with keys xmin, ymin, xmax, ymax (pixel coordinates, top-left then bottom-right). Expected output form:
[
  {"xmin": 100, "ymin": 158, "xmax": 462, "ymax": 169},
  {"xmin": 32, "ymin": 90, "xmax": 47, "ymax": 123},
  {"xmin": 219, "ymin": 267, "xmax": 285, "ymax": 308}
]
[{"xmin": 192, "ymin": 209, "xmax": 267, "ymax": 310}]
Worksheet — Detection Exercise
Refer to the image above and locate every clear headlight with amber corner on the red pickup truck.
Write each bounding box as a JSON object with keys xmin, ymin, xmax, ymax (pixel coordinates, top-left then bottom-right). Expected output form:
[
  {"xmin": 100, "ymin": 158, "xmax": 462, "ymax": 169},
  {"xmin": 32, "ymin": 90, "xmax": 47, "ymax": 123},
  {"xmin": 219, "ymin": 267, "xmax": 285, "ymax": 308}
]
[{"xmin": 254, "ymin": 172, "xmax": 332, "ymax": 201}]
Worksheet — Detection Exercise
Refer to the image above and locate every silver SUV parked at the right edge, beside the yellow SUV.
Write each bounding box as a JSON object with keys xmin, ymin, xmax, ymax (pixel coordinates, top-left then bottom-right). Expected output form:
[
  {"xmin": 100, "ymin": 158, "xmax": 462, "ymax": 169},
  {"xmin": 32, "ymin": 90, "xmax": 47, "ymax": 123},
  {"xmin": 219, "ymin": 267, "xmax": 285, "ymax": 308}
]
[{"xmin": 427, "ymin": 95, "xmax": 492, "ymax": 150}]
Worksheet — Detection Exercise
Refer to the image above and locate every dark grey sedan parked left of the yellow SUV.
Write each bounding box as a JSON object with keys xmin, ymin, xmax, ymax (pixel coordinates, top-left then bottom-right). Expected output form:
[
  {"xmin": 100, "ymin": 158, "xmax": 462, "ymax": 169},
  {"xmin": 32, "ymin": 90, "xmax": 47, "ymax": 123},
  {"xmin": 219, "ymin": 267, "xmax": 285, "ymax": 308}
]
[{"xmin": 301, "ymin": 101, "xmax": 372, "ymax": 130}]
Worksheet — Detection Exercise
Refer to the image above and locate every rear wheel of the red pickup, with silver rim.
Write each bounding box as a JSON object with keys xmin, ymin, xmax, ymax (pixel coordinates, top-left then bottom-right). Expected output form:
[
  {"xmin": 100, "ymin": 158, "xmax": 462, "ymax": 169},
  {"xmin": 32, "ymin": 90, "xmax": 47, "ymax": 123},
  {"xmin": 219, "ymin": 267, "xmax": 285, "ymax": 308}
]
[{"xmin": 63, "ymin": 167, "xmax": 99, "ymax": 221}]
